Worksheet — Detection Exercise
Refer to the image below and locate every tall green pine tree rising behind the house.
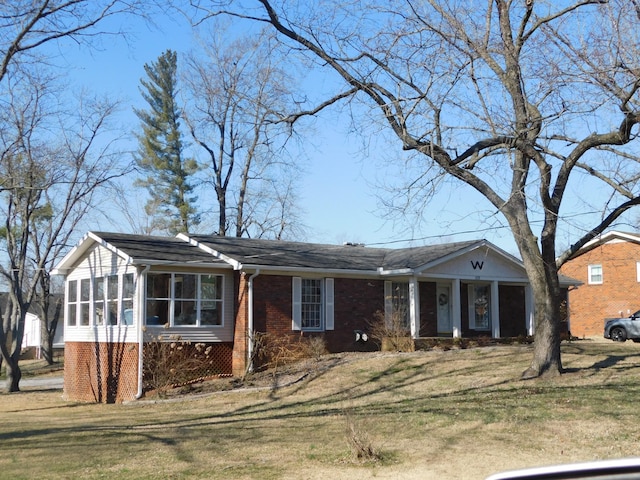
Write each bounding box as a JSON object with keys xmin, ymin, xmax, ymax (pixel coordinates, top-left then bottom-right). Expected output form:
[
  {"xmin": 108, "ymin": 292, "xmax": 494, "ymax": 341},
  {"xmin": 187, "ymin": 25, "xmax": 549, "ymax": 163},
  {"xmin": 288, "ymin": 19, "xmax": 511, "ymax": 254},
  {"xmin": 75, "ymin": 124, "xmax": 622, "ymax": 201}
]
[{"xmin": 134, "ymin": 50, "xmax": 199, "ymax": 234}]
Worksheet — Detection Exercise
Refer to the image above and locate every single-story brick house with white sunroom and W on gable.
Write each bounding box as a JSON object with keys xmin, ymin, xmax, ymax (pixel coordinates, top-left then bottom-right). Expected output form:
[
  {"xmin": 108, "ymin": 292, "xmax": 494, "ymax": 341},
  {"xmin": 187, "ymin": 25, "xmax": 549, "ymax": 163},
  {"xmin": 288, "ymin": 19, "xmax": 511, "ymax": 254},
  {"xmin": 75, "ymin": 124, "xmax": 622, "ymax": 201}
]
[{"xmin": 52, "ymin": 232, "xmax": 576, "ymax": 402}]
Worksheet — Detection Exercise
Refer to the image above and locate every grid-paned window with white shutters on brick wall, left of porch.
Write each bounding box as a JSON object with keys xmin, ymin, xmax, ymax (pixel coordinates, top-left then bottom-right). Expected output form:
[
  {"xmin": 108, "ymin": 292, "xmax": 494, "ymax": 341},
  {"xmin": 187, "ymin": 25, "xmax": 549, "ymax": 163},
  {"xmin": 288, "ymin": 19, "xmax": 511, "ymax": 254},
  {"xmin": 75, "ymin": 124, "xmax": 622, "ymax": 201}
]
[{"xmin": 292, "ymin": 277, "xmax": 333, "ymax": 331}]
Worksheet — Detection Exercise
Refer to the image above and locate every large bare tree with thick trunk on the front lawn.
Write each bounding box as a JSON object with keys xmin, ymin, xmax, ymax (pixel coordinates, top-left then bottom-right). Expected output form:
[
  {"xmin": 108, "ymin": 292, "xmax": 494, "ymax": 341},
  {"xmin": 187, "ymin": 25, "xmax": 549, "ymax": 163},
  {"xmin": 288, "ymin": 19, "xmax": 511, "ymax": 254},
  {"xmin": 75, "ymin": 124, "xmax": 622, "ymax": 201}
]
[{"xmin": 191, "ymin": 0, "xmax": 640, "ymax": 378}]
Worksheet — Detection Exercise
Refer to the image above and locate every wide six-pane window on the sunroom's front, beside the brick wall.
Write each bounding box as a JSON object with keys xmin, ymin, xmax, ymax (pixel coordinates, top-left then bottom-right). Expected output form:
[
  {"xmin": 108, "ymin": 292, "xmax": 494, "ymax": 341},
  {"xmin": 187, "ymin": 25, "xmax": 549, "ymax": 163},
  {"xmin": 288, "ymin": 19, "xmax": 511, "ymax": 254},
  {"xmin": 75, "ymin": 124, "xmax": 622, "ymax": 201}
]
[{"xmin": 146, "ymin": 273, "xmax": 223, "ymax": 326}]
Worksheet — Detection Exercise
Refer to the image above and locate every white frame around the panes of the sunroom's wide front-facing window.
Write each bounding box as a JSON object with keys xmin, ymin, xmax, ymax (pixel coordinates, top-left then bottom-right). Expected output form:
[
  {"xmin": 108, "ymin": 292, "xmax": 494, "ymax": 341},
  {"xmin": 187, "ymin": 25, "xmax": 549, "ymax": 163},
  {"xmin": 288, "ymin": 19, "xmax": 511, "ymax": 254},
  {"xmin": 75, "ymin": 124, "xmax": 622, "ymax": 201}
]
[{"xmin": 144, "ymin": 271, "xmax": 225, "ymax": 328}]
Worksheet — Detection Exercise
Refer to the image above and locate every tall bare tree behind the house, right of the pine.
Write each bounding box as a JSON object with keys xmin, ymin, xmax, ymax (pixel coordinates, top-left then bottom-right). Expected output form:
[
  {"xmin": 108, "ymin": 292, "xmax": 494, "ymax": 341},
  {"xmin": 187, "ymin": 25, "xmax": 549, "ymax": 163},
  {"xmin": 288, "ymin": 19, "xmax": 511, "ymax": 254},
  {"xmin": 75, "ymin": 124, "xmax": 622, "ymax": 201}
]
[{"xmin": 185, "ymin": 25, "xmax": 308, "ymax": 237}]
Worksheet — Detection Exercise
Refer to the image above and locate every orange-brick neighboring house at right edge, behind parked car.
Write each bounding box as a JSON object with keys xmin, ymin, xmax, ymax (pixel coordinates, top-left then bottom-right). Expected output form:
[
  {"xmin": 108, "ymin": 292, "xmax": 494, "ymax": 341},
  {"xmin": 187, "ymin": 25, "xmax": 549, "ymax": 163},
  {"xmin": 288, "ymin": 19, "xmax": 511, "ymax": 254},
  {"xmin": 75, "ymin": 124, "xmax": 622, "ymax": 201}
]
[{"xmin": 560, "ymin": 231, "xmax": 640, "ymax": 337}]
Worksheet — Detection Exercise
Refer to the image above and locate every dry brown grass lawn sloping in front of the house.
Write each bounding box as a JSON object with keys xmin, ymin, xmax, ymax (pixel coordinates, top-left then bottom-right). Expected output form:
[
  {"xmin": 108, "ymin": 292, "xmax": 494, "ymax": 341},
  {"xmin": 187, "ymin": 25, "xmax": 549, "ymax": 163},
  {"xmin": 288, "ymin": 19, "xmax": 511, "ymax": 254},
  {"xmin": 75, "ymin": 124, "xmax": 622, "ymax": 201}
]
[{"xmin": 0, "ymin": 340, "xmax": 640, "ymax": 480}]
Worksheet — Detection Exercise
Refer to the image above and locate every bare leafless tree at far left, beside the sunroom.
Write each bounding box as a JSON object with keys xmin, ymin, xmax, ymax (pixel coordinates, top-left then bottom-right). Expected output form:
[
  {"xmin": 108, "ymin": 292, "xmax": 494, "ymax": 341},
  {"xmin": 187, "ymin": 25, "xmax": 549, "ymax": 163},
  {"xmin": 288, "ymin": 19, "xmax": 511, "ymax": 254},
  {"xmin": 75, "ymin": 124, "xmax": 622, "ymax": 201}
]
[{"xmin": 0, "ymin": 66, "xmax": 132, "ymax": 392}]
